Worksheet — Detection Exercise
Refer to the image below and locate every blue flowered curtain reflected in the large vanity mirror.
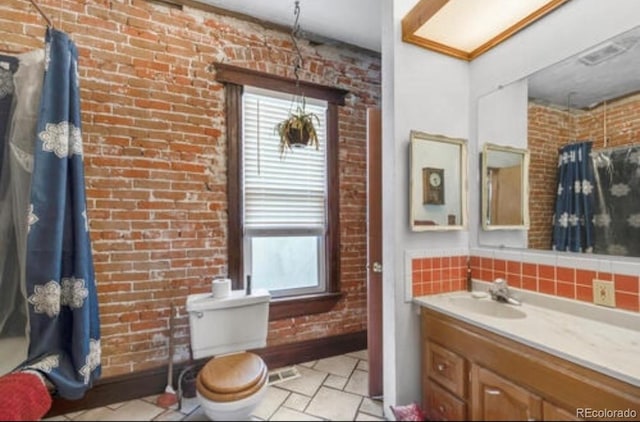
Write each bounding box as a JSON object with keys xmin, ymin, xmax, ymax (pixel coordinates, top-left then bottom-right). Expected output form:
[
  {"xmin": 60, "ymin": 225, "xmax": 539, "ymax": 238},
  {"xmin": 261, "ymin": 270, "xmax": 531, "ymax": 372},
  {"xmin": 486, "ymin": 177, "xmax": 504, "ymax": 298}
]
[{"xmin": 552, "ymin": 141, "xmax": 594, "ymax": 252}]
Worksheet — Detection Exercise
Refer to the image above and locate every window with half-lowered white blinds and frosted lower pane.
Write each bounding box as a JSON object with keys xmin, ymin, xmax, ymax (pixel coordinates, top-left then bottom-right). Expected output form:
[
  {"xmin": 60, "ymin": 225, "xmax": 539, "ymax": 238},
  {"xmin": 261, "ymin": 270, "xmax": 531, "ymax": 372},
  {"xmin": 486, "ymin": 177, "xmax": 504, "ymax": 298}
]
[{"xmin": 242, "ymin": 87, "xmax": 327, "ymax": 297}]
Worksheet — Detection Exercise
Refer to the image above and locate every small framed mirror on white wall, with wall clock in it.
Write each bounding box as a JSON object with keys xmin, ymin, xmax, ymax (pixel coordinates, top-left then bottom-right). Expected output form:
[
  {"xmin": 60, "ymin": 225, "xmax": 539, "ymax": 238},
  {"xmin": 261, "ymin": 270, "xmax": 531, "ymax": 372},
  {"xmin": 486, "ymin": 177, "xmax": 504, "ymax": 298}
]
[{"xmin": 409, "ymin": 131, "xmax": 467, "ymax": 231}]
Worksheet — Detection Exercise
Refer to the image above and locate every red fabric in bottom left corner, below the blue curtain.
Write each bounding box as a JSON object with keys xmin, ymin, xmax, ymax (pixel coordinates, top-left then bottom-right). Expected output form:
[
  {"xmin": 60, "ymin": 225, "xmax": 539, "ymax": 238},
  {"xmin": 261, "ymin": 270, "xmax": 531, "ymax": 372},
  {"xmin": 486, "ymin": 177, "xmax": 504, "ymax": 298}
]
[{"xmin": 0, "ymin": 372, "xmax": 51, "ymax": 421}]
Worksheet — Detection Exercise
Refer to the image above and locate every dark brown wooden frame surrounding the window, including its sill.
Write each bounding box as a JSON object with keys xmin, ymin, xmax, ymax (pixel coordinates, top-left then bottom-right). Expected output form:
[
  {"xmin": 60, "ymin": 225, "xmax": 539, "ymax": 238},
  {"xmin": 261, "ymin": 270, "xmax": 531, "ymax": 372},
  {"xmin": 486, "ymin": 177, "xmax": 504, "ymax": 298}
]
[{"xmin": 215, "ymin": 63, "xmax": 349, "ymax": 321}]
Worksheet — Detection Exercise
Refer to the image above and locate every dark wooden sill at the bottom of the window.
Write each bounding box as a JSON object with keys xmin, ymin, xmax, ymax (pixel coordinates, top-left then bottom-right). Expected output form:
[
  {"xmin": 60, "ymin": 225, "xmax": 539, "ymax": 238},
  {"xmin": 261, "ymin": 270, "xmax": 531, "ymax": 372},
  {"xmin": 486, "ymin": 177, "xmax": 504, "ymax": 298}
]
[{"xmin": 269, "ymin": 292, "xmax": 342, "ymax": 321}]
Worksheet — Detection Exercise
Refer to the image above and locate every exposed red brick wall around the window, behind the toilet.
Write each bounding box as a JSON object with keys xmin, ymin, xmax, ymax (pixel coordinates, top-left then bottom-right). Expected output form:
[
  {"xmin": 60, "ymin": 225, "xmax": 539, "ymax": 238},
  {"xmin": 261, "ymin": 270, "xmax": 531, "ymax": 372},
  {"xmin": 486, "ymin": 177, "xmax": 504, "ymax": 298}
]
[{"xmin": 0, "ymin": 0, "xmax": 381, "ymax": 377}]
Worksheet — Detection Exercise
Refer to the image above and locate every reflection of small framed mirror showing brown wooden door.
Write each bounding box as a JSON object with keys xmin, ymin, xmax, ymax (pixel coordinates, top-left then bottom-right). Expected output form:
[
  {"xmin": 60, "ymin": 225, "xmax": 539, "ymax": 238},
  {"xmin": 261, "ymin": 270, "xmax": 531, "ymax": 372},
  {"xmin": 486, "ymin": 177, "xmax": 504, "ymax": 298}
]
[{"xmin": 481, "ymin": 144, "xmax": 529, "ymax": 230}]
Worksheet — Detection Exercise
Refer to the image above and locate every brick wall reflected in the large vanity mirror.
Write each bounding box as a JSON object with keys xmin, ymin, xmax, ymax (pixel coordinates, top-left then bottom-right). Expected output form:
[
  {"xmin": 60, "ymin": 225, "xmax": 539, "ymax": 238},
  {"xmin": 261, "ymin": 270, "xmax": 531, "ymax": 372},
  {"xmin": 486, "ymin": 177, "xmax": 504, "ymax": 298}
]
[{"xmin": 528, "ymin": 94, "xmax": 640, "ymax": 250}]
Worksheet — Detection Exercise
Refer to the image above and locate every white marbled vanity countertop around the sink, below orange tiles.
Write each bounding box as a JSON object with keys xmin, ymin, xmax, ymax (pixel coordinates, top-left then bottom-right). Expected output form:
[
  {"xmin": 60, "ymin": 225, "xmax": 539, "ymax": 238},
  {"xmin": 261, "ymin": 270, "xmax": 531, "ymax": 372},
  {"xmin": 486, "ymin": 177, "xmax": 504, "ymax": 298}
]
[{"xmin": 413, "ymin": 281, "xmax": 640, "ymax": 387}]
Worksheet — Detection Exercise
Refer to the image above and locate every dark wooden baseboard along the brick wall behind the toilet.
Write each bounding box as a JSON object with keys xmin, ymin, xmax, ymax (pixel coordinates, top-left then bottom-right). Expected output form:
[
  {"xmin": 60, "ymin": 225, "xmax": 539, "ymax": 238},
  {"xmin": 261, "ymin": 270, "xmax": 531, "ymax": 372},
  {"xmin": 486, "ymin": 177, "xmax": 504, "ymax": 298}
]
[{"xmin": 45, "ymin": 331, "xmax": 367, "ymax": 418}]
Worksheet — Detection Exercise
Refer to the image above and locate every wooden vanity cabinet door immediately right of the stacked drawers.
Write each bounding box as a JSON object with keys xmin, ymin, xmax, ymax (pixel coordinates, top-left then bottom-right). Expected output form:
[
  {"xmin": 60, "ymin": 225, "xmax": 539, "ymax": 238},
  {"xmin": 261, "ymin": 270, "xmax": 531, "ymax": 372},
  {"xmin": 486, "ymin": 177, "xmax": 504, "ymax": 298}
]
[{"xmin": 471, "ymin": 365, "xmax": 542, "ymax": 421}]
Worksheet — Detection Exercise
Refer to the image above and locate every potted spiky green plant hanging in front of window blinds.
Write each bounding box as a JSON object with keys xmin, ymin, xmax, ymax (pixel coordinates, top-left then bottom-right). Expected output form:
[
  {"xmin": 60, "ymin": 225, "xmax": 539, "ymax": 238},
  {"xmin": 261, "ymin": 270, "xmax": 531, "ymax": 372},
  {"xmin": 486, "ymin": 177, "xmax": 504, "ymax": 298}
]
[{"xmin": 276, "ymin": 98, "xmax": 320, "ymax": 158}]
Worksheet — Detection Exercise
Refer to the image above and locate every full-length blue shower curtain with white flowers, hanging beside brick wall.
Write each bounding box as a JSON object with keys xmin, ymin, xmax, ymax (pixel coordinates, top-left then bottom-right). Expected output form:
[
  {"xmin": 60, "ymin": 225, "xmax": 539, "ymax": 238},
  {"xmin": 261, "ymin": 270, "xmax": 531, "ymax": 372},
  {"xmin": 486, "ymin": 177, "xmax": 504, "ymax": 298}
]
[{"xmin": 0, "ymin": 29, "xmax": 101, "ymax": 399}]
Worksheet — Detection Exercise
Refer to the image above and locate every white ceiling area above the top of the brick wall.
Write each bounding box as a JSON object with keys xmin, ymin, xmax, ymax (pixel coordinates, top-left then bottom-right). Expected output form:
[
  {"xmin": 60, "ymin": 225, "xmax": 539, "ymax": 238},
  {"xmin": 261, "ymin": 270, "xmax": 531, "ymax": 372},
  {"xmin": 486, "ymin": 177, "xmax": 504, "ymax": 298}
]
[{"xmin": 198, "ymin": 0, "xmax": 382, "ymax": 53}]
